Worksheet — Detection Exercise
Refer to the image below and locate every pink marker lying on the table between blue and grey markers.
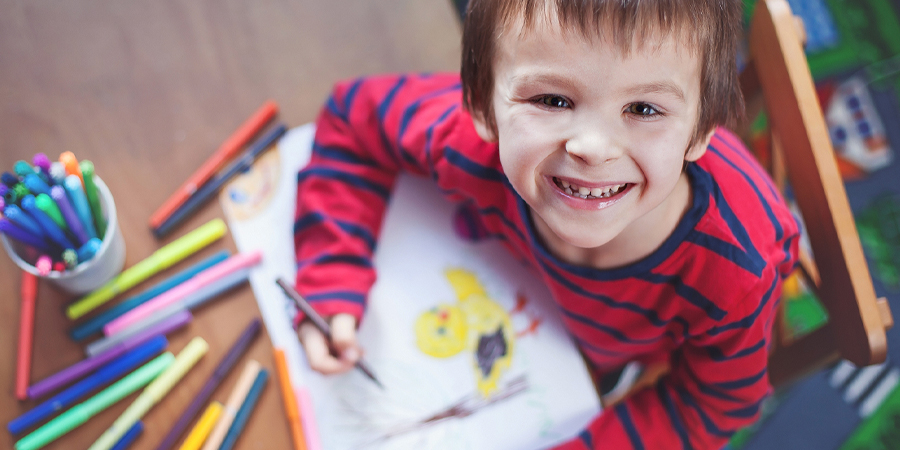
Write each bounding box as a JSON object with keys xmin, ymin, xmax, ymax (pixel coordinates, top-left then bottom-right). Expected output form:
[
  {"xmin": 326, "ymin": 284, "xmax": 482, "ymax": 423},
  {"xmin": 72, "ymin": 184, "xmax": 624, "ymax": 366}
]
[{"xmin": 103, "ymin": 250, "xmax": 262, "ymax": 336}]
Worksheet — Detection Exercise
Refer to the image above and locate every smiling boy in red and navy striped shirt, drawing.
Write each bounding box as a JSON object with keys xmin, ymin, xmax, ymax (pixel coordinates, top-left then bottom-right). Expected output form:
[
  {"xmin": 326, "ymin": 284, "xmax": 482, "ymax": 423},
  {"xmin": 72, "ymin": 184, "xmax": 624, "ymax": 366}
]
[{"xmin": 295, "ymin": 0, "xmax": 798, "ymax": 449}]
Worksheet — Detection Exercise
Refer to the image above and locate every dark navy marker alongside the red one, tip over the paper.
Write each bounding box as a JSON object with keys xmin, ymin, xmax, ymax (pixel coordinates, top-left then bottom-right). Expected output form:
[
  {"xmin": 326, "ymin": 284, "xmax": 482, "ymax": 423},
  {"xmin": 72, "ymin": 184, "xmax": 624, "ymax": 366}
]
[{"xmin": 153, "ymin": 124, "xmax": 287, "ymax": 238}]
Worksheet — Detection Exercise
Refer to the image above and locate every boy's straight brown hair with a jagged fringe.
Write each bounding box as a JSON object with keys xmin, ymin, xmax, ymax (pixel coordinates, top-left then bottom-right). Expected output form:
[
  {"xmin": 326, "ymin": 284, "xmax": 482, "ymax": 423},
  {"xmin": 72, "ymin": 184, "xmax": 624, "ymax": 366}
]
[{"xmin": 461, "ymin": 0, "xmax": 744, "ymax": 145}]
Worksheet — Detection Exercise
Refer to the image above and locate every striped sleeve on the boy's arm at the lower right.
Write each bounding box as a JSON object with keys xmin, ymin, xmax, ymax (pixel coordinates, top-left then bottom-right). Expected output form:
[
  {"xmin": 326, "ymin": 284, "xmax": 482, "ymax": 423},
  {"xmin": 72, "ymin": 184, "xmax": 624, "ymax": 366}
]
[{"xmin": 557, "ymin": 268, "xmax": 782, "ymax": 450}]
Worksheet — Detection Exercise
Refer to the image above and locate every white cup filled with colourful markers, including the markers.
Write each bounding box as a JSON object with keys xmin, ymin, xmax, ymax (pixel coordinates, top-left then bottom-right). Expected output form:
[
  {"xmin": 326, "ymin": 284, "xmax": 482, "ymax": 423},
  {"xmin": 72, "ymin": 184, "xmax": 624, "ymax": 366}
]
[{"xmin": 0, "ymin": 152, "xmax": 125, "ymax": 294}]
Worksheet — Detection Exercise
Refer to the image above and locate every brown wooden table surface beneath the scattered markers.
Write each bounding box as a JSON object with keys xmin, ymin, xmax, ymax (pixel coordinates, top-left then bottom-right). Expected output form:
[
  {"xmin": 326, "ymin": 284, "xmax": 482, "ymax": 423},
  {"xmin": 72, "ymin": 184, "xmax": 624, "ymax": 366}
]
[{"xmin": 0, "ymin": 0, "xmax": 460, "ymax": 449}]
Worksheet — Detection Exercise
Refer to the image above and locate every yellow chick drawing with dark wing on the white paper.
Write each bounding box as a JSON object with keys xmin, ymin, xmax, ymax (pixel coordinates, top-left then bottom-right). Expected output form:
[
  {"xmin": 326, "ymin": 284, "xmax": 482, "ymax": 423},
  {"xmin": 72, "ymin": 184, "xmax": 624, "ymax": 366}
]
[{"xmin": 415, "ymin": 269, "xmax": 537, "ymax": 398}]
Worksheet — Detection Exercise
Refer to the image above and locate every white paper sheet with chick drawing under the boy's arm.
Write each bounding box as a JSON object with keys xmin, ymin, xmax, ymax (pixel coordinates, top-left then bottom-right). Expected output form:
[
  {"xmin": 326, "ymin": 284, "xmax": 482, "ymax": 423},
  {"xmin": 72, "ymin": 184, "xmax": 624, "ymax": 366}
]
[{"xmin": 221, "ymin": 125, "xmax": 600, "ymax": 450}]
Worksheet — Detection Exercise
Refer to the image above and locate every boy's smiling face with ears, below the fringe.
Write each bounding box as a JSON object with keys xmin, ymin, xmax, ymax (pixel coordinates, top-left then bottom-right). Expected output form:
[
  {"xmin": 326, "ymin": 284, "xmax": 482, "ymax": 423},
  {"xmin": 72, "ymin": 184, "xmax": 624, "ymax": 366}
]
[{"xmin": 475, "ymin": 18, "xmax": 709, "ymax": 266}]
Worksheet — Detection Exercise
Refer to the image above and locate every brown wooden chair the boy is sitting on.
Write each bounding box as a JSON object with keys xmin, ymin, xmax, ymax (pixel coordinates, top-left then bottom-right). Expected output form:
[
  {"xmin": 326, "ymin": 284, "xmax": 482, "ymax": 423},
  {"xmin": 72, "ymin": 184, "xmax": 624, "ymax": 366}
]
[{"xmin": 604, "ymin": 0, "xmax": 893, "ymax": 406}]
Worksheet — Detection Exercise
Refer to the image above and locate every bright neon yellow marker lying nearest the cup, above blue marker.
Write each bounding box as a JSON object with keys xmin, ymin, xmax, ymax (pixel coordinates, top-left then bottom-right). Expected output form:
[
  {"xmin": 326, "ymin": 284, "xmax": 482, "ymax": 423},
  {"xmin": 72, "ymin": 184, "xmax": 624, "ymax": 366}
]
[{"xmin": 66, "ymin": 219, "xmax": 227, "ymax": 320}]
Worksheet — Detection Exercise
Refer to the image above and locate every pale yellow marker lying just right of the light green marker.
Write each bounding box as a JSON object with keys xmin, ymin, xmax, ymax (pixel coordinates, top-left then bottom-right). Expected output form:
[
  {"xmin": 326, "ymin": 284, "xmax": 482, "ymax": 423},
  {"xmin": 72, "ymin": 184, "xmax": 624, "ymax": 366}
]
[{"xmin": 88, "ymin": 336, "xmax": 209, "ymax": 450}]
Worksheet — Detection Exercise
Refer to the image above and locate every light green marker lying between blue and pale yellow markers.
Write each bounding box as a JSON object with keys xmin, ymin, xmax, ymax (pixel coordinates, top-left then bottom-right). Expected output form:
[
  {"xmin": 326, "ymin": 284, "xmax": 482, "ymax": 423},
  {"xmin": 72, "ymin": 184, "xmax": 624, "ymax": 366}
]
[{"xmin": 16, "ymin": 352, "xmax": 175, "ymax": 450}]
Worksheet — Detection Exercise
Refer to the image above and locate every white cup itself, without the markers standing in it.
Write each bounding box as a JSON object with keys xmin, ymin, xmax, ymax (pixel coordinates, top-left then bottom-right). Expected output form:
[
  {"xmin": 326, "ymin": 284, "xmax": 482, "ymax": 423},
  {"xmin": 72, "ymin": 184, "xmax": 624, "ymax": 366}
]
[{"xmin": 0, "ymin": 176, "xmax": 125, "ymax": 295}]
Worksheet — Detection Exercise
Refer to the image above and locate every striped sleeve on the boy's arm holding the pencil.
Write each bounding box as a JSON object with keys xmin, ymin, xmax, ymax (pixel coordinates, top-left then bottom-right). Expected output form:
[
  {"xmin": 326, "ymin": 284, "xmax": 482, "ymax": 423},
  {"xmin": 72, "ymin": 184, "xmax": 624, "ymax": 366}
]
[{"xmin": 293, "ymin": 74, "xmax": 461, "ymax": 324}]
